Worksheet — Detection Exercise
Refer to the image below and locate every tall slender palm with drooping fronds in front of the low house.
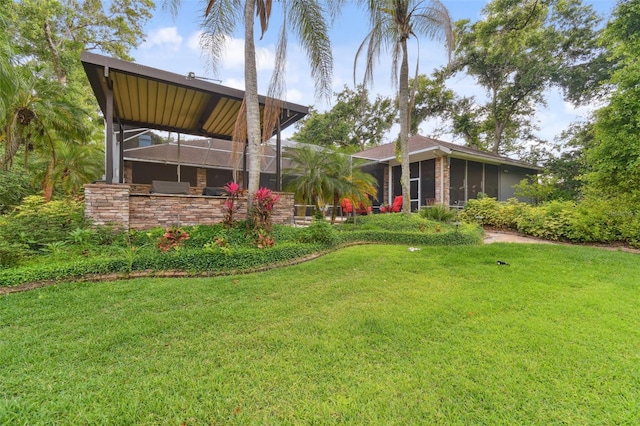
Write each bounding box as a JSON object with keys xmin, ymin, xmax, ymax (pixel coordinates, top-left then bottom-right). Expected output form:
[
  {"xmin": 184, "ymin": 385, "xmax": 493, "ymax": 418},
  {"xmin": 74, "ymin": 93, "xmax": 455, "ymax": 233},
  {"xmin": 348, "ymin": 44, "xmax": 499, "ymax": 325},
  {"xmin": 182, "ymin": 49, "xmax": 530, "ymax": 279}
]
[{"xmin": 353, "ymin": 0, "xmax": 454, "ymax": 213}]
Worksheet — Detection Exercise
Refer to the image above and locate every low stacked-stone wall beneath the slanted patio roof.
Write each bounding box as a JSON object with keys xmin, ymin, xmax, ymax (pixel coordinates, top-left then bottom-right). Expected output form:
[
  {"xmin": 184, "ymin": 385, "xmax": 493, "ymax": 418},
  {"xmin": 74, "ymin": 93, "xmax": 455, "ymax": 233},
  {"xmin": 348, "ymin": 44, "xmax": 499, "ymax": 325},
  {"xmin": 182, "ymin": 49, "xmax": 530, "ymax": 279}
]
[{"xmin": 85, "ymin": 183, "xmax": 294, "ymax": 229}]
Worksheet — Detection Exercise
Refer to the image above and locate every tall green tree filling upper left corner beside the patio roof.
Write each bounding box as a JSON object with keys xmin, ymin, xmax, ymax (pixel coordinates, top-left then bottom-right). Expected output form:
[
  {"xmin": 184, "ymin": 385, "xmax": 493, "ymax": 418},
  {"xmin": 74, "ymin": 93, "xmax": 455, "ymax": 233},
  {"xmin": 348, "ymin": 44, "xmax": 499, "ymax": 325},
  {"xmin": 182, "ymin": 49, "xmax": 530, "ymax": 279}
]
[{"xmin": 0, "ymin": 0, "xmax": 154, "ymax": 199}]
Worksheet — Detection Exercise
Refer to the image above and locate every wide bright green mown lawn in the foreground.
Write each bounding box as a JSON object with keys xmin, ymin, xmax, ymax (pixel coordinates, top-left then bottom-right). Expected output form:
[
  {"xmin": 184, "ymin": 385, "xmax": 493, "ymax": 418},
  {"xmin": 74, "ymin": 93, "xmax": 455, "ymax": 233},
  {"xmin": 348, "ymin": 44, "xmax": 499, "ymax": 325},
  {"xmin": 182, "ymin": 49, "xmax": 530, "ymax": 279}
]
[{"xmin": 0, "ymin": 244, "xmax": 640, "ymax": 425}]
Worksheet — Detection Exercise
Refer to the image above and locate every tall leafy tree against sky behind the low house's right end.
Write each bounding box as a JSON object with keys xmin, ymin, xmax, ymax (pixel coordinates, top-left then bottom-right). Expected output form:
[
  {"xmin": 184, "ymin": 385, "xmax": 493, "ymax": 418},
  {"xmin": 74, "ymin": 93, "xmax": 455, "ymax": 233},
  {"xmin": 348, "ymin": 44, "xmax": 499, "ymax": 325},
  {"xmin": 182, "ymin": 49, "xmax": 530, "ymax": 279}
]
[{"xmin": 449, "ymin": 0, "xmax": 600, "ymax": 154}]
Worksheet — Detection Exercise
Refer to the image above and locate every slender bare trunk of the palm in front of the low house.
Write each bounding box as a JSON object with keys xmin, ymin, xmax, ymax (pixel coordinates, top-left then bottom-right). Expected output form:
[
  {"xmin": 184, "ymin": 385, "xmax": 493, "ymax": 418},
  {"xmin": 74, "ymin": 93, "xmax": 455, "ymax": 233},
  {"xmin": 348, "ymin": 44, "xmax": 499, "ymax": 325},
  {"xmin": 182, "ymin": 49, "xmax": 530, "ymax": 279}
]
[{"xmin": 398, "ymin": 40, "xmax": 411, "ymax": 214}]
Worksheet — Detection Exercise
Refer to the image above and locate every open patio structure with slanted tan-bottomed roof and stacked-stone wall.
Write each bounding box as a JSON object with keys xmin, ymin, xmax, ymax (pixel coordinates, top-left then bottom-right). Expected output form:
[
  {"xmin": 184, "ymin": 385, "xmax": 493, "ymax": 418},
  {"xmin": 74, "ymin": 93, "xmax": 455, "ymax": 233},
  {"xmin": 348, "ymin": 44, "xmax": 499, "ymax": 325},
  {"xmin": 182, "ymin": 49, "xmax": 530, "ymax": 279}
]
[{"xmin": 81, "ymin": 51, "xmax": 308, "ymax": 229}]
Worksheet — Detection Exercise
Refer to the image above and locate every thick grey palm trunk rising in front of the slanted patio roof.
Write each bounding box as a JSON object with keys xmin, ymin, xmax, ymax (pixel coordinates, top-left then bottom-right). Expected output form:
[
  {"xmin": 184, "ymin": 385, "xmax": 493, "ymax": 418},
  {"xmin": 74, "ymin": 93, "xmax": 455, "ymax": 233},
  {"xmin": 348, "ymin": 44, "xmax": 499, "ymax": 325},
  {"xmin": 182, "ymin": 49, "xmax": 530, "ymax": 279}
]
[{"xmin": 244, "ymin": 0, "xmax": 262, "ymax": 213}]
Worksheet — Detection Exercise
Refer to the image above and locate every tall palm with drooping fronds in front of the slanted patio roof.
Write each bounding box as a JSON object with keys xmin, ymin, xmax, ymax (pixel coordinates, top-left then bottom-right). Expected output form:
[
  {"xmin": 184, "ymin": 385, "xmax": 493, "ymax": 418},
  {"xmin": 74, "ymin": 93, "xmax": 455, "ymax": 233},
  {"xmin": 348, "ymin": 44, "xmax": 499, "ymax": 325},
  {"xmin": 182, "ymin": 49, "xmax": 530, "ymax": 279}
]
[{"xmin": 165, "ymin": 0, "xmax": 342, "ymax": 213}]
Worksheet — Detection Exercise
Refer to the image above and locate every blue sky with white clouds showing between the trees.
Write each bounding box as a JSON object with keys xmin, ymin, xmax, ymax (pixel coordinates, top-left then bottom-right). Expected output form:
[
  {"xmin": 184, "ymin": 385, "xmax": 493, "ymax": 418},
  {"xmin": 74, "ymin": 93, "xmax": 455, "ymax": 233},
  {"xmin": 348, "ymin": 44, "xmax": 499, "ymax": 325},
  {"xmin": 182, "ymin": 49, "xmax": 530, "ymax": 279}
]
[{"xmin": 132, "ymin": 0, "xmax": 615, "ymax": 143}]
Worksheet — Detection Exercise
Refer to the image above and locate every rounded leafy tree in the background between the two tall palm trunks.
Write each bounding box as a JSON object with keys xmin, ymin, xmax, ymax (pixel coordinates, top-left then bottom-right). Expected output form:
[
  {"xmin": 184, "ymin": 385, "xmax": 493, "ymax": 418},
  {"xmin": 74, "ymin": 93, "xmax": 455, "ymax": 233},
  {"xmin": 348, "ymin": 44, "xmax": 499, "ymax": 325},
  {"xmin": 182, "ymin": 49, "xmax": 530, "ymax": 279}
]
[{"xmin": 292, "ymin": 85, "xmax": 397, "ymax": 152}]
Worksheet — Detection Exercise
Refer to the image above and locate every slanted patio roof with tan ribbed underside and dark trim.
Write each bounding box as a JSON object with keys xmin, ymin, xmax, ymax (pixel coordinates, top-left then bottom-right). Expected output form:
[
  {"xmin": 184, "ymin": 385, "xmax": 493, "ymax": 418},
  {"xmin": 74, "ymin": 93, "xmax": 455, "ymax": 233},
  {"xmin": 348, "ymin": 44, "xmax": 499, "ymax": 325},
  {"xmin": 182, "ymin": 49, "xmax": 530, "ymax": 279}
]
[{"xmin": 81, "ymin": 51, "xmax": 309, "ymax": 140}]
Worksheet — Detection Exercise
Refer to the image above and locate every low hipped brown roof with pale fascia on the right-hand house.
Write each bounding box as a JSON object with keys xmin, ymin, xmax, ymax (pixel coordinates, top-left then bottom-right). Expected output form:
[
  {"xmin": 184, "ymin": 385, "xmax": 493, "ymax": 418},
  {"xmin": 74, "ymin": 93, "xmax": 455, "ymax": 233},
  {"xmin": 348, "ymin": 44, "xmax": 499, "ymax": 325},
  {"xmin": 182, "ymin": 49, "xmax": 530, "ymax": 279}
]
[{"xmin": 353, "ymin": 135, "xmax": 542, "ymax": 170}]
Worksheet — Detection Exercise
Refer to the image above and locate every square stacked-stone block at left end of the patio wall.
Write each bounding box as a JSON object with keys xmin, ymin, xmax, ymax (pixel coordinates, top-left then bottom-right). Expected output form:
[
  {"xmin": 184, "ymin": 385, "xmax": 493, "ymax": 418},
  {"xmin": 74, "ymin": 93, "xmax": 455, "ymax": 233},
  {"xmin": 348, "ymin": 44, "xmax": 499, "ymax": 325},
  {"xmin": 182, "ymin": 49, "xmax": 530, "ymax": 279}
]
[{"xmin": 84, "ymin": 183, "xmax": 130, "ymax": 229}]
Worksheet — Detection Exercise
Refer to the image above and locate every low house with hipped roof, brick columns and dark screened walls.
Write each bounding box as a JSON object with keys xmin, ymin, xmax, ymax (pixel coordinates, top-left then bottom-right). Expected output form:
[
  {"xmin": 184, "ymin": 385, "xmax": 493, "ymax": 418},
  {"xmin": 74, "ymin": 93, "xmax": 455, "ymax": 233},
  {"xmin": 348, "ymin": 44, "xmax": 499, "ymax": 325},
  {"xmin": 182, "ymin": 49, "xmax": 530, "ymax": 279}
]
[{"xmin": 353, "ymin": 135, "xmax": 542, "ymax": 211}]
